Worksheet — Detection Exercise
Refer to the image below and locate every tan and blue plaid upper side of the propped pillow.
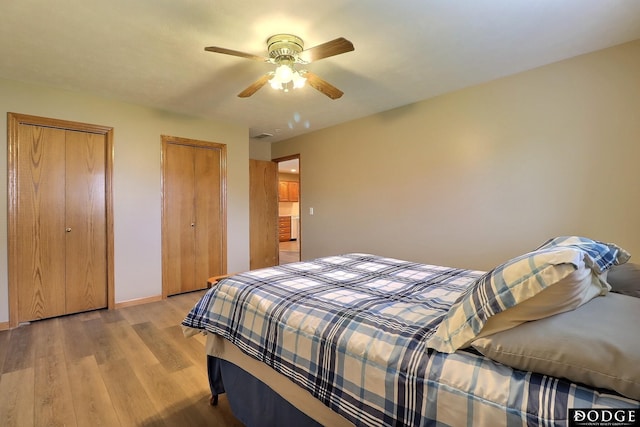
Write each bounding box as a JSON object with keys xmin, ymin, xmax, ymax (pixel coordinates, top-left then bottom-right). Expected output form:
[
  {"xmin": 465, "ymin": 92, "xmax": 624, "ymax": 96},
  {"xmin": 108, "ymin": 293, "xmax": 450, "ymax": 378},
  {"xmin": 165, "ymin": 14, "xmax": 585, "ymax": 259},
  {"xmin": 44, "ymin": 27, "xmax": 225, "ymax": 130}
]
[{"xmin": 427, "ymin": 246, "xmax": 597, "ymax": 353}]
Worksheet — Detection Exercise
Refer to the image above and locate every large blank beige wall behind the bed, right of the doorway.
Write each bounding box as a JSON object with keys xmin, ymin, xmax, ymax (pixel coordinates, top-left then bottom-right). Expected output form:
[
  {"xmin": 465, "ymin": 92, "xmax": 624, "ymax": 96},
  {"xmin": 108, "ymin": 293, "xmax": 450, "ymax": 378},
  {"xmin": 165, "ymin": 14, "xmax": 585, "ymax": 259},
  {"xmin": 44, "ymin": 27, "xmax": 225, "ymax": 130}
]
[{"xmin": 272, "ymin": 41, "xmax": 640, "ymax": 270}]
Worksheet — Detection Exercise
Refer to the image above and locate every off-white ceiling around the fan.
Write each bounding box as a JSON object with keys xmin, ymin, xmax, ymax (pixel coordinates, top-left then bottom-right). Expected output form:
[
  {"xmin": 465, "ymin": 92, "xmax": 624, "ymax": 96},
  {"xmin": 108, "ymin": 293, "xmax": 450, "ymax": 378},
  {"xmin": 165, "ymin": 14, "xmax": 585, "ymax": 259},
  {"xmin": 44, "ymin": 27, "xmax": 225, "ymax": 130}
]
[{"xmin": 0, "ymin": 0, "xmax": 640, "ymax": 142}]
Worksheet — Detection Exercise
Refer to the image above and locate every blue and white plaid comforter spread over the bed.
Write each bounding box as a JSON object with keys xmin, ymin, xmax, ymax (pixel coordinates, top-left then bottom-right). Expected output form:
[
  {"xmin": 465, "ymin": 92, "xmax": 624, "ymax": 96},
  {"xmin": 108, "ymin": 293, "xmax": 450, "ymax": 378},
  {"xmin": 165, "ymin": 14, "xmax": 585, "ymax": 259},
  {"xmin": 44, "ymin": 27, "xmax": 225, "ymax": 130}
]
[{"xmin": 183, "ymin": 254, "xmax": 638, "ymax": 426}]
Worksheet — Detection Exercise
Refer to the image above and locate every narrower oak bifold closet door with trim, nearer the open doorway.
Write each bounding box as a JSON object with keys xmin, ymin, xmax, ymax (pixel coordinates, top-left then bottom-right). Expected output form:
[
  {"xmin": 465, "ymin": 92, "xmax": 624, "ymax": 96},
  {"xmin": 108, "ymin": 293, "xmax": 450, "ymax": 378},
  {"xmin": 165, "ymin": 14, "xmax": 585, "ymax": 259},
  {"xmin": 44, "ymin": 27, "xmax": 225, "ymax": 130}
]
[{"xmin": 162, "ymin": 136, "xmax": 226, "ymax": 297}]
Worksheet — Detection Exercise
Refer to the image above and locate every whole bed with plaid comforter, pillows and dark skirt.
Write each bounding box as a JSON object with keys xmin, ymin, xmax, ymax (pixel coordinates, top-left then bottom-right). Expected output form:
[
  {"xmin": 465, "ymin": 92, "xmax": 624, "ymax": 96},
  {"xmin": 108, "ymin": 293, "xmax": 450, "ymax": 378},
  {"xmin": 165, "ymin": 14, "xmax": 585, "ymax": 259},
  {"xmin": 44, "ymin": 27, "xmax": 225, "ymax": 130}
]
[{"xmin": 182, "ymin": 236, "xmax": 640, "ymax": 426}]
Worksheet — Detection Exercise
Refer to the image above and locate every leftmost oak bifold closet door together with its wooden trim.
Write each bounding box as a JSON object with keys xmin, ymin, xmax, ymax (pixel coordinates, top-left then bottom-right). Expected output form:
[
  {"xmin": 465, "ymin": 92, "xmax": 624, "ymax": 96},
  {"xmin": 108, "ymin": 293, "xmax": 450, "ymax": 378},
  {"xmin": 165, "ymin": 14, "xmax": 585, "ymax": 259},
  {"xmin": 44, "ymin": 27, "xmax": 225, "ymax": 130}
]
[{"xmin": 7, "ymin": 113, "xmax": 115, "ymax": 328}]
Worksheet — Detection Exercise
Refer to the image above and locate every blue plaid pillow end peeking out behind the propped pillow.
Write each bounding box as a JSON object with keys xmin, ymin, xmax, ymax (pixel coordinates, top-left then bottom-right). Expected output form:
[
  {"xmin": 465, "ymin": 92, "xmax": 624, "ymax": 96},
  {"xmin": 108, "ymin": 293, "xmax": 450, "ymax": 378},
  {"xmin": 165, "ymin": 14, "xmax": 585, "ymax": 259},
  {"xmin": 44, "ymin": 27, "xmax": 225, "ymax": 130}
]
[{"xmin": 538, "ymin": 236, "xmax": 631, "ymax": 274}]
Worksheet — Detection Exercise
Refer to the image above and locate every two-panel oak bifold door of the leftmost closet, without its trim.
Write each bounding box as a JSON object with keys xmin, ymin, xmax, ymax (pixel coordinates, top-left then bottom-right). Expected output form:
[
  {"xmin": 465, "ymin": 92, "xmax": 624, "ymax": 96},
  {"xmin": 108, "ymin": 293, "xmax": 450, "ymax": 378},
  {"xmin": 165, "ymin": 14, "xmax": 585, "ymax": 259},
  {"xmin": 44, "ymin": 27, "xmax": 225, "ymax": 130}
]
[{"xmin": 15, "ymin": 124, "xmax": 107, "ymax": 322}]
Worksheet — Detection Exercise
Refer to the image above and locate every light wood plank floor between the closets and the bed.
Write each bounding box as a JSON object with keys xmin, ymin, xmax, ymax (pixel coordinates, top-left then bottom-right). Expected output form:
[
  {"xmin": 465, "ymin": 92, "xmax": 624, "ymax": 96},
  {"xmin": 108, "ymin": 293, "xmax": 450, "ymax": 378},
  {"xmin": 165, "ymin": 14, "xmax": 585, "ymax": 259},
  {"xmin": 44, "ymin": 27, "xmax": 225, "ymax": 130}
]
[{"xmin": 0, "ymin": 291, "xmax": 241, "ymax": 427}]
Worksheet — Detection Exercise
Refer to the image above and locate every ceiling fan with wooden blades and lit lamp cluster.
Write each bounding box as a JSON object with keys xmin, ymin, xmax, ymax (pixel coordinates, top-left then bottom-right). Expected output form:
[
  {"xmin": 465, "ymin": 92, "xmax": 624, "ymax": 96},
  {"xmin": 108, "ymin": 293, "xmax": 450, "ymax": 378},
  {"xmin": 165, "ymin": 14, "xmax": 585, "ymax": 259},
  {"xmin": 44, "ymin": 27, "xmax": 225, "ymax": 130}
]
[{"xmin": 204, "ymin": 34, "xmax": 354, "ymax": 99}]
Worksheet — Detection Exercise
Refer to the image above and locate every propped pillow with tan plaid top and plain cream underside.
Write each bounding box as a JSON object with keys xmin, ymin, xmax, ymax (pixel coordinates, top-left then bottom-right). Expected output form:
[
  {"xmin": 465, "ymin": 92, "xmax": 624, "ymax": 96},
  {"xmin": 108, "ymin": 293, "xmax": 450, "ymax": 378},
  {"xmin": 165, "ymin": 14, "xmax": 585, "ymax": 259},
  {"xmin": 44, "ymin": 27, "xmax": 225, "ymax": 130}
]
[{"xmin": 427, "ymin": 246, "xmax": 607, "ymax": 353}]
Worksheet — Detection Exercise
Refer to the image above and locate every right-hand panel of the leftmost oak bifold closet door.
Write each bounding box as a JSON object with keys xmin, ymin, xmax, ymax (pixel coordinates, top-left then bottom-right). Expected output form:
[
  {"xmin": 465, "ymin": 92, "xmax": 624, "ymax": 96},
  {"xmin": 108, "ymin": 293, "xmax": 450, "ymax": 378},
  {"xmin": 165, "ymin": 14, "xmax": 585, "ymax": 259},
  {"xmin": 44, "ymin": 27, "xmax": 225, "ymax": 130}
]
[{"xmin": 65, "ymin": 131, "xmax": 107, "ymax": 313}]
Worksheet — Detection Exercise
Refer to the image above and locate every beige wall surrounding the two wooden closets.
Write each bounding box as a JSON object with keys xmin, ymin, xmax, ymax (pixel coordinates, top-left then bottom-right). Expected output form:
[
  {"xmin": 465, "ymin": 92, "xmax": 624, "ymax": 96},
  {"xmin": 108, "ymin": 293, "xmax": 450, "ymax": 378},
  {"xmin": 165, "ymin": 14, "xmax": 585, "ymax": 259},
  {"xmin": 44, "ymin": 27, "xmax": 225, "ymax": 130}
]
[{"xmin": 0, "ymin": 79, "xmax": 249, "ymax": 323}]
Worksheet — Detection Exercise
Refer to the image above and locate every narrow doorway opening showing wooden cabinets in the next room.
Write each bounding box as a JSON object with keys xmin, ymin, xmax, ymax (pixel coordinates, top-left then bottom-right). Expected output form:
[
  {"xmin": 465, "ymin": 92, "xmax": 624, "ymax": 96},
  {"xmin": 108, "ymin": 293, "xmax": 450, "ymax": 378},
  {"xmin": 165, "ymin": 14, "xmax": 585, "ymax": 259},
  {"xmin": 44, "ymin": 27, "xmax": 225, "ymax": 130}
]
[{"xmin": 274, "ymin": 154, "xmax": 302, "ymax": 265}]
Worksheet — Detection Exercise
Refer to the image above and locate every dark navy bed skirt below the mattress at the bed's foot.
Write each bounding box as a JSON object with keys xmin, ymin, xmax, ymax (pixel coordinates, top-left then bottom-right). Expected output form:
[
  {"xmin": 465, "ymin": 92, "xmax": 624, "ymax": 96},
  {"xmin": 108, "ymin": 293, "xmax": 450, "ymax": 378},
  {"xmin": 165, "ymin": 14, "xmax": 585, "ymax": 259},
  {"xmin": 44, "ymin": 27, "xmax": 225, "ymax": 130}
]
[{"xmin": 207, "ymin": 356, "xmax": 321, "ymax": 427}]
